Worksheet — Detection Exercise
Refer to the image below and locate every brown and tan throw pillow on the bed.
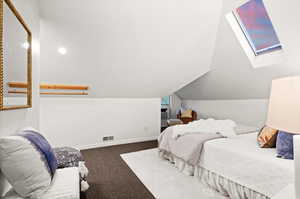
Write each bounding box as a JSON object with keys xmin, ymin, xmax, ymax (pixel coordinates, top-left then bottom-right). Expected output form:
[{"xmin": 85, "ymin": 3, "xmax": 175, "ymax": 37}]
[{"xmin": 257, "ymin": 126, "xmax": 278, "ymax": 148}]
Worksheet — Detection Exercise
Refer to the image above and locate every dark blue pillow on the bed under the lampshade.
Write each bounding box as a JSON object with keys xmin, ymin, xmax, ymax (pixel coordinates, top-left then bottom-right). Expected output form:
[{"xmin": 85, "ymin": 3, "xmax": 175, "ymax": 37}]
[{"xmin": 276, "ymin": 131, "xmax": 294, "ymax": 160}]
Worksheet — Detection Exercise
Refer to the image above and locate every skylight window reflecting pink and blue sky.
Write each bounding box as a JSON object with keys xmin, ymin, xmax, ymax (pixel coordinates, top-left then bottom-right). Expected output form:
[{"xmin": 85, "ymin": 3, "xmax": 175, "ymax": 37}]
[{"xmin": 233, "ymin": 0, "xmax": 282, "ymax": 56}]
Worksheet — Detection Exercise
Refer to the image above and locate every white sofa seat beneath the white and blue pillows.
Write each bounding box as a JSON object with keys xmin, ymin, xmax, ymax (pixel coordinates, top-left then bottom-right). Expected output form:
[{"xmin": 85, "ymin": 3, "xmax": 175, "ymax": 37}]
[{"xmin": 0, "ymin": 167, "xmax": 80, "ymax": 199}]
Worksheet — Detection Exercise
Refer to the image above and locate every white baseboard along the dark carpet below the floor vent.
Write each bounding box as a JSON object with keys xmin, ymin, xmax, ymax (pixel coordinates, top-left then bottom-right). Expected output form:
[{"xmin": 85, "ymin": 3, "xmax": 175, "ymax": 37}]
[{"xmin": 76, "ymin": 136, "xmax": 158, "ymax": 150}]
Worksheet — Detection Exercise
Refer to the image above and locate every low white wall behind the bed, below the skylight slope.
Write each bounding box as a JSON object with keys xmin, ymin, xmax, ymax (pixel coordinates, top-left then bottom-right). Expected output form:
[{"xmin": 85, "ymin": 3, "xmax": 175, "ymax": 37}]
[{"xmin": 184, "ymin": 99, "xmax": 268, "ymax": 127}]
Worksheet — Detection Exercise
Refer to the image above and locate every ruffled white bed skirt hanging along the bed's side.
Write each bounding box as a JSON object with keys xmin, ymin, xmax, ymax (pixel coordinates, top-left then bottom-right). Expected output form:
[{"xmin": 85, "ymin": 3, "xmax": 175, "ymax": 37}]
[{"xmin": 159, "ymin": 150, "xmax": 270, "ymax": 199}]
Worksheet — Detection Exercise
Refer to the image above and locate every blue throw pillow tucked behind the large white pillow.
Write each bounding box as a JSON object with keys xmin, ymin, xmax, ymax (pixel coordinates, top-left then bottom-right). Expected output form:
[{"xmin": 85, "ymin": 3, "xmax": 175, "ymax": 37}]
[{"xmin": 18, "ymin": 130, "xmax": 57, "ymax": 178}]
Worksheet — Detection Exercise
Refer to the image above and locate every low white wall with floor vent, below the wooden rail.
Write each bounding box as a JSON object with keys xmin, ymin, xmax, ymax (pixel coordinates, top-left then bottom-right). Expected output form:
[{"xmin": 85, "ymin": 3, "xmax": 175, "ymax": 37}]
[{"xmin": 40, "ymin": 98, "xmax": 160, "ymax": 149}]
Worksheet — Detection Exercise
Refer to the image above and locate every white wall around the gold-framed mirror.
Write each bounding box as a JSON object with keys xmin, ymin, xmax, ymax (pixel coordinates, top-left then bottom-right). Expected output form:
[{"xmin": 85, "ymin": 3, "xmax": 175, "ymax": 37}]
[{"xmin": 0, "ymin": 0, "xmax": 40, "ymax": 197}]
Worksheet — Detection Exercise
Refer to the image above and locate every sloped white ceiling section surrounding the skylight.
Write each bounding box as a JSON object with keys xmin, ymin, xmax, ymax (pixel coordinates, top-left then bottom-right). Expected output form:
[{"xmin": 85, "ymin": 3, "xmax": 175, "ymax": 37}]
[{"xmin": 177, "ymin": 0, "xmax": 300, "ymax": 100}]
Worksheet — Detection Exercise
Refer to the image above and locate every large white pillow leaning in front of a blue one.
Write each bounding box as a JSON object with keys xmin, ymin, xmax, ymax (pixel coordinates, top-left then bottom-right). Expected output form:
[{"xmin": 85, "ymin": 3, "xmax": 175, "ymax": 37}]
[{"xmin": 0, "ymin": 136, "xmax": 51, "ymax": 199}]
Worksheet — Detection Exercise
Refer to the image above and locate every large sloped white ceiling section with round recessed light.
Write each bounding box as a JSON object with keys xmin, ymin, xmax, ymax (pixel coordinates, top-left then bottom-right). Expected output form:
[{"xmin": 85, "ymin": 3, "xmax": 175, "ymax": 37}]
[{"xmin": 40, "ymin": 0, "xmax": 222, "ymax": 97}]
